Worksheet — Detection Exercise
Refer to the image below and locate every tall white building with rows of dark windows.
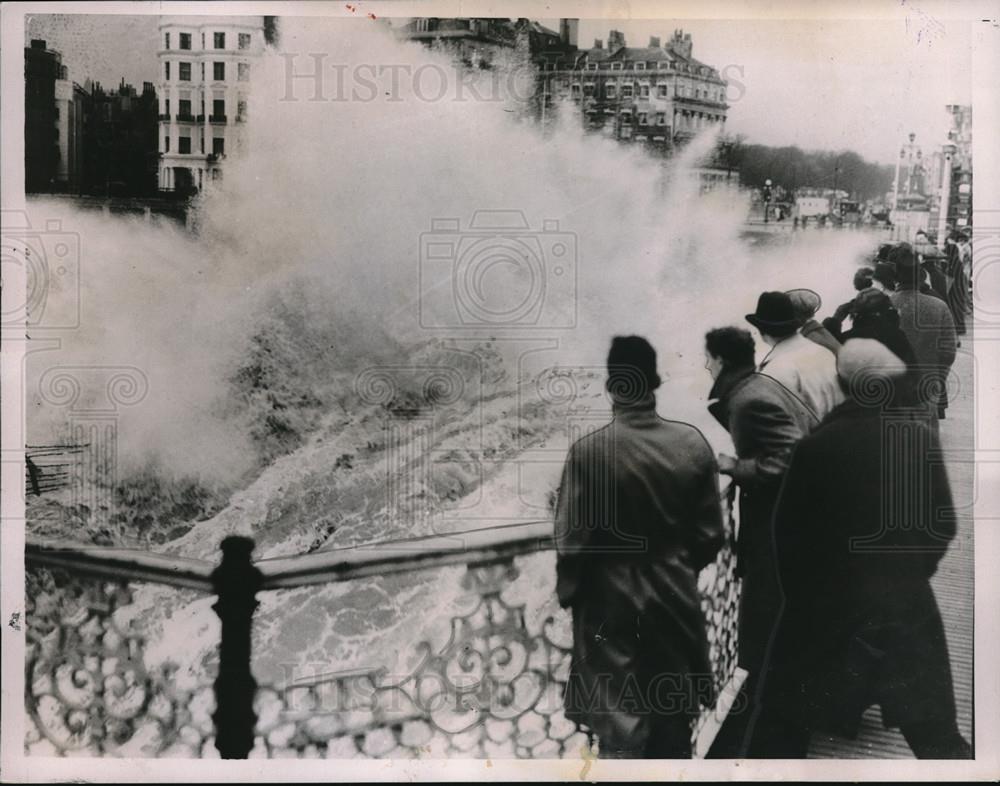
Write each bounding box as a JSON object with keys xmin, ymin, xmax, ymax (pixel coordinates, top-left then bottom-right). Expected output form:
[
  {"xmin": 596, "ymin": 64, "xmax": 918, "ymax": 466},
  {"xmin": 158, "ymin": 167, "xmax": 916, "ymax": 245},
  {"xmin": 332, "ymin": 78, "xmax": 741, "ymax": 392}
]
[{"xmin": 158, "ymin": 16, "xmax": 274, "ymax": 195}]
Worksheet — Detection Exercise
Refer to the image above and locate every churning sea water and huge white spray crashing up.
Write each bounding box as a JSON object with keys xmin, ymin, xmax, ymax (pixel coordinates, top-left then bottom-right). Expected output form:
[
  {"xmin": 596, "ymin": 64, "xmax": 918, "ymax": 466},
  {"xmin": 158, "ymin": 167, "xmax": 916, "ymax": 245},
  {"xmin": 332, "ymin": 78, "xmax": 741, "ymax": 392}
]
[{"xmin": 21, "ymin": 19, "xmax": 878, "ymax": 752}]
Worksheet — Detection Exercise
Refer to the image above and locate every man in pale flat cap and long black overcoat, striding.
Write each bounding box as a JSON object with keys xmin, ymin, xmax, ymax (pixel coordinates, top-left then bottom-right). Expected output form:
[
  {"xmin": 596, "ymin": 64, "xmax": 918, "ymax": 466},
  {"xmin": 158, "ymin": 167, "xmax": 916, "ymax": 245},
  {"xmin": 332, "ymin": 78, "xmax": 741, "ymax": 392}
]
[{"xmin": 750, "ymin": 339, "xmax": 970, "ymax": 758}]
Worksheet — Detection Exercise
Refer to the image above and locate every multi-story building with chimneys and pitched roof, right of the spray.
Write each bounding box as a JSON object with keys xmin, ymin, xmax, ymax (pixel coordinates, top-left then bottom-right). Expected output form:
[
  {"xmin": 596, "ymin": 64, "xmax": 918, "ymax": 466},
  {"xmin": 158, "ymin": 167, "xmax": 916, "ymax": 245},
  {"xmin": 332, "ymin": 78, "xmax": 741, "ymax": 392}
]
[{"xmin": 536, "ymin": 30, "xmax": 728, "ymax": 150}]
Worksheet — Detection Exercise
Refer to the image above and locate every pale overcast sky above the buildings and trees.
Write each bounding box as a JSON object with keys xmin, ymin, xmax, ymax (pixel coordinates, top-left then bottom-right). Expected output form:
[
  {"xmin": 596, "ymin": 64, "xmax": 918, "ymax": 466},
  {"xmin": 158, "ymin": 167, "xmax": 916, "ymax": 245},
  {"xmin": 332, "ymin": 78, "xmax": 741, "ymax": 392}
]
[{"xmin": 26, "ymin": 15, "xmax": 972, "ymax": 163}]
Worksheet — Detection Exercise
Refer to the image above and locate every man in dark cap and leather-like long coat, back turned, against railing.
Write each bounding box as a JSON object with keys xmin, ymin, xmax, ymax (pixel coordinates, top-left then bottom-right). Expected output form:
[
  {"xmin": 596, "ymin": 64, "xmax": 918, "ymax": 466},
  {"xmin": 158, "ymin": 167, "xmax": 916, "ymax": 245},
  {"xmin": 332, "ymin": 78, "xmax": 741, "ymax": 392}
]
[{"xmin": 555, "ymin": 336, "xmax": 723, "ymax": 758}]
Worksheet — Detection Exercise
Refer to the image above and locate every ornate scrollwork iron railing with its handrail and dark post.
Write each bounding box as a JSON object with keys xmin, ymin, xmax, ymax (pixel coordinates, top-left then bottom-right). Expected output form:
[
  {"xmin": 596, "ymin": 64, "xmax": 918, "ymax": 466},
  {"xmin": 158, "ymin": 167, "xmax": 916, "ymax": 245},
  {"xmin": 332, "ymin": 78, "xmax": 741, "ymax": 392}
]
[{"xmin": 25, "ymin": 486, "xmax": 742, "ymax": 758}]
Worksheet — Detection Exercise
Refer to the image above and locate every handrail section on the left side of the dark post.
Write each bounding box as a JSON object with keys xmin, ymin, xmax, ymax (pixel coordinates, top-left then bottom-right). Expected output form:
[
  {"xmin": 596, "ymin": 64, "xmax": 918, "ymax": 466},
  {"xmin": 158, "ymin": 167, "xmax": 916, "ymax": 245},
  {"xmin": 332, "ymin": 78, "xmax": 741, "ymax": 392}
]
[{"xmin": 24, "ymin": 538, "xmax": 215, "ymax": 592}]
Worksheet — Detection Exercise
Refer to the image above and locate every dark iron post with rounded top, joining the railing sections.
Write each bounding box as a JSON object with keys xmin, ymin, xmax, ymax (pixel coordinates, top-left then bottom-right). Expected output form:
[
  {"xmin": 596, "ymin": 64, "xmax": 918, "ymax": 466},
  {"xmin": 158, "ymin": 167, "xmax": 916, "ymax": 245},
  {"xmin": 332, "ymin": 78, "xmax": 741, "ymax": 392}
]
[{"xmin": 212, "ymin": 536, "xmax": 261, "ymax": 759}]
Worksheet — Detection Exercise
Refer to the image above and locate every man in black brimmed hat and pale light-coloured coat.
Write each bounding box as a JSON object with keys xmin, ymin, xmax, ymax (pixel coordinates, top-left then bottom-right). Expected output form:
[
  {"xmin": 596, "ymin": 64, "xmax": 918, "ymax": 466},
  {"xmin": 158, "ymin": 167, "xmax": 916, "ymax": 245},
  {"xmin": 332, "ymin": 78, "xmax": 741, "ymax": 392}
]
[{"xmin": 746, "ymin": 292, "xmax": 844, "ymax": 420}]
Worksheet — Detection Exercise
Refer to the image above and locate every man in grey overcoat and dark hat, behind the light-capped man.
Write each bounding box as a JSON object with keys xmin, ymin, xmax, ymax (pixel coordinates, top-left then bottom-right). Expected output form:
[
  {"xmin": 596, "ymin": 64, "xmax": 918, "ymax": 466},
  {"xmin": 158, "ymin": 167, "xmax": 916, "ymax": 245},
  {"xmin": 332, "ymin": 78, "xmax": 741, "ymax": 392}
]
[{"xmin": 889, "ymin": 243, "xmax": 958, "ymax": 418}]
